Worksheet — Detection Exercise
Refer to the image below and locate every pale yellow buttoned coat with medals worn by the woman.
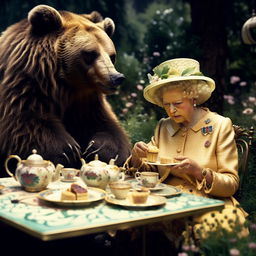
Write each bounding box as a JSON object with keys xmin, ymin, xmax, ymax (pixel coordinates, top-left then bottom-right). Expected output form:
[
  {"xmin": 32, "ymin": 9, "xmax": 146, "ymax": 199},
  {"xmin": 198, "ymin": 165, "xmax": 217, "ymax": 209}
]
[{"xmin": 134, "ymin": 109, "xmax": 247, "ymax": 234}]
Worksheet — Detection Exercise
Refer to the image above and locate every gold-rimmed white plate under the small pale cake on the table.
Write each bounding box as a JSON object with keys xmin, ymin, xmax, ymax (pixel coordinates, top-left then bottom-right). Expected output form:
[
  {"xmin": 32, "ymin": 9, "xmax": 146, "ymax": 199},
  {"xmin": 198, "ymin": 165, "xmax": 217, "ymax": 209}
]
[{"xmin": 105, "ymin": 194, "xmax": 166, "ymax": 208}]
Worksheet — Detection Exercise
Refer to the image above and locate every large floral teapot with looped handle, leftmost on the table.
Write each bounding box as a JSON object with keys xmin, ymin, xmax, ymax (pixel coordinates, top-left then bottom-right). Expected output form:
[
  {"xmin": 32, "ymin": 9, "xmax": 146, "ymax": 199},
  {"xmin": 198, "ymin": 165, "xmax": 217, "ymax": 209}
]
[{"xmin": 5, "ymin": 149, "xmax": 64, "ymax": 192}]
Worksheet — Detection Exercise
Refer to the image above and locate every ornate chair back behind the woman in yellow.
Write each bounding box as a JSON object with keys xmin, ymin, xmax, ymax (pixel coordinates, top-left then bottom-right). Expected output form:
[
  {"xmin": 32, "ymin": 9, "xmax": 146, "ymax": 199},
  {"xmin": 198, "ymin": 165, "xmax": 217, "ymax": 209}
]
[{"xmin": 233, "ymin": 125, "xmax": 254, "ymax": 198}]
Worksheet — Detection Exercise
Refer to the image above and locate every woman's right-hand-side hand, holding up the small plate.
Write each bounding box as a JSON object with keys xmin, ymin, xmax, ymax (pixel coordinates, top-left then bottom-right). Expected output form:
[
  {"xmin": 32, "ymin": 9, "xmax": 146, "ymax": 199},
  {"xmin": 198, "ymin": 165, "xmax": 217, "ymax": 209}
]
[{"xmin": 173, "ymin": 156, "xmax": 203, "ymax": 181}]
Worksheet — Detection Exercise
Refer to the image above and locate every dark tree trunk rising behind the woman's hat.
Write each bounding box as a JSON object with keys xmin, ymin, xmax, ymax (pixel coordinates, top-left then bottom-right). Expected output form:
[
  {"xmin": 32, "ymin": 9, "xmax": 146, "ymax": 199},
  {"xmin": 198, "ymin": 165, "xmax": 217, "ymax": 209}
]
[{"xmin": 189, "ymin": 0, "xmax": 229, "ymax": 114}]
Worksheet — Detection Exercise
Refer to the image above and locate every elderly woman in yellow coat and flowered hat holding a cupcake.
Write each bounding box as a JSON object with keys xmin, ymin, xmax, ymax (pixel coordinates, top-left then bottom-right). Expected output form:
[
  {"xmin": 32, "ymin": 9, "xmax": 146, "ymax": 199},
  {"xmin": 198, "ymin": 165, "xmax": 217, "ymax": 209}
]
[{"xmin": 128, "ymin": 58, "xmax": 247, "ymax": 242}]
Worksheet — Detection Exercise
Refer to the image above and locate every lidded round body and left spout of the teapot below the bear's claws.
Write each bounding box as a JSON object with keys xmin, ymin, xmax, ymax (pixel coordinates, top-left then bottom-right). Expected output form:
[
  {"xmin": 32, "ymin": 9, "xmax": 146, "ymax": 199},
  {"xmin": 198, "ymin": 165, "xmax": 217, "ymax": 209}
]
[{"xmin": 80, "ymin": 154, "xmax": 110, "ymax": 189}]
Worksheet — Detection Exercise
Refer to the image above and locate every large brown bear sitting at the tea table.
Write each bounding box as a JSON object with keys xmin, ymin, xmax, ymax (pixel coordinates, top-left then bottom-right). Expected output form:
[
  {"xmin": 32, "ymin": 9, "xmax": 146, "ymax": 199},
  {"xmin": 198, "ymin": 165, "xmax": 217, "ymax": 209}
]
[{"xmin": 0, "ymin": 5, "xmax": 130, "ymax": 176}]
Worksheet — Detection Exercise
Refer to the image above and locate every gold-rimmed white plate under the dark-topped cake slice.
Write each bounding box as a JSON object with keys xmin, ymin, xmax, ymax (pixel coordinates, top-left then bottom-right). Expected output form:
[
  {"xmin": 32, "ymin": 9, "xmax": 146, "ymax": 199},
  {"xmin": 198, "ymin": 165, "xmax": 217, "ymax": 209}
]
[{"xmin": 38, "ymin": 187, "xmax": 106, "ymax": 206}]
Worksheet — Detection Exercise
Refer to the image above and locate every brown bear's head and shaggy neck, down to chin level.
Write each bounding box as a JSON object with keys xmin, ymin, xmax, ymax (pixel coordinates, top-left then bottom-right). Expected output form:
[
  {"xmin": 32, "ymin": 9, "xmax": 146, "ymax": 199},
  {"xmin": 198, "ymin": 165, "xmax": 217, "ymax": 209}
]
[{"xmin": 0, "ymin": 5, "xmax": 124, "ymax": 99}]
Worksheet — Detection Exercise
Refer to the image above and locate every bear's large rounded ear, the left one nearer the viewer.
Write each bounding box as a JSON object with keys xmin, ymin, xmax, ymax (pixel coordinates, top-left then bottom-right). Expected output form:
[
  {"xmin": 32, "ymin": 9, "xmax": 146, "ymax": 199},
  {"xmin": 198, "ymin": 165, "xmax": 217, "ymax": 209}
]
[{"xmin": 28, "ymin": 5, "xmax": 62, "ymax": 34}]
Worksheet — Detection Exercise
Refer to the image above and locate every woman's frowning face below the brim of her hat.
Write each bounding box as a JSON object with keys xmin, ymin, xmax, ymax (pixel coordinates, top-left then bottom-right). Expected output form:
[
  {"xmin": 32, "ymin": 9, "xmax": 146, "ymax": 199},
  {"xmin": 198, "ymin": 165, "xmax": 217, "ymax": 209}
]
[{"xmin": 163, "ymin": 88, "xmax": 194, "ymax": 125}]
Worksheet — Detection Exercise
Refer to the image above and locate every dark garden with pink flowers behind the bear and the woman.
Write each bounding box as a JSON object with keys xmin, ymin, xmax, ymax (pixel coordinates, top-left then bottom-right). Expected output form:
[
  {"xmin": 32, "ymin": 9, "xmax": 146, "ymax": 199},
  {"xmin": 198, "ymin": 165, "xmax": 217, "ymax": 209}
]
[{"xmin": 0, "ymin": 0, "xmax": 256, "ymax": 255}]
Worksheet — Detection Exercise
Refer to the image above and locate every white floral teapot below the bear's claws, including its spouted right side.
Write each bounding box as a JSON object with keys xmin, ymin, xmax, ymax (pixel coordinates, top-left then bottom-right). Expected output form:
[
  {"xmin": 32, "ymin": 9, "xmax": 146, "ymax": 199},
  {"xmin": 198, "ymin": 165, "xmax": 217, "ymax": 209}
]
[{"xmin": 80, "ymin": 154, "xmax": 125, "ymax": 189}]
